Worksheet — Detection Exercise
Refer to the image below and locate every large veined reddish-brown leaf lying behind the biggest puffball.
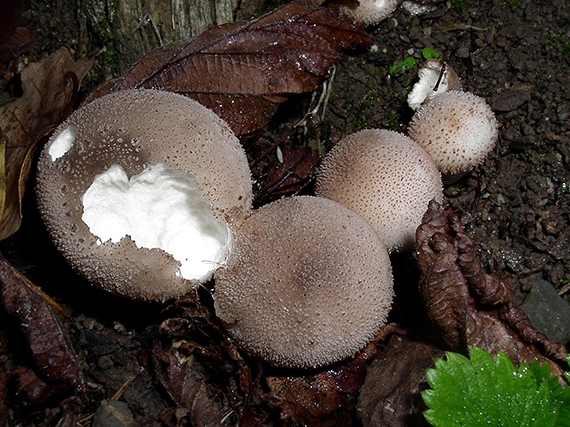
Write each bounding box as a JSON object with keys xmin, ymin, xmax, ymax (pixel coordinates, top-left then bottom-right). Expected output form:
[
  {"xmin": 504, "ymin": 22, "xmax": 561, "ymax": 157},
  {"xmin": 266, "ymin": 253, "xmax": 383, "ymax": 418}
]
[{"xmin": 115, "ymin": 0, "xmax": 371, "ymax": 135}]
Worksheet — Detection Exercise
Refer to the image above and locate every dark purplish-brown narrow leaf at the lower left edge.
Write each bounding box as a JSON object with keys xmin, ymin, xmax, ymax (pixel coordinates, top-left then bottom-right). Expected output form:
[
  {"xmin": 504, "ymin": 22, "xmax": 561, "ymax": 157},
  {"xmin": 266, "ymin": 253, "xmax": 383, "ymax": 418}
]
[{"xmin": 0, "ymin": 256, "xmax": 85, "ymax": 396}]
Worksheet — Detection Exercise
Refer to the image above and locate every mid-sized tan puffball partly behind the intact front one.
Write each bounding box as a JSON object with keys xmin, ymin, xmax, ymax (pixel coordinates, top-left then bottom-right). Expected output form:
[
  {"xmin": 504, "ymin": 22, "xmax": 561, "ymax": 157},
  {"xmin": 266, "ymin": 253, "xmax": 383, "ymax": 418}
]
[{"xmin": 315, "ymin": 129, "xmax": 443, "ymax": 252}]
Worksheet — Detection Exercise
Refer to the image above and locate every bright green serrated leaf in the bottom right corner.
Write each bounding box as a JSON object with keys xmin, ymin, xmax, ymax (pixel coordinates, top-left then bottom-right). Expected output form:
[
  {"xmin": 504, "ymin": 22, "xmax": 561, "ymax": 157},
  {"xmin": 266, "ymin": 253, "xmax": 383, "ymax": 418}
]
[{"xmin": 422, "ymin": 347, "xmax": 570, "ymax": 427}]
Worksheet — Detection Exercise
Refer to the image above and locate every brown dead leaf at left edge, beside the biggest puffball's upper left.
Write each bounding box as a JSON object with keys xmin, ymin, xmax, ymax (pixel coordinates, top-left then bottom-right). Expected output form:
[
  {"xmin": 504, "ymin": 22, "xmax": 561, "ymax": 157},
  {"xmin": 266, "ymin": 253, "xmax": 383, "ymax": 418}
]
[{"xmin": 0, "ymin": 47, "xmax": 93, "ymax": 240}]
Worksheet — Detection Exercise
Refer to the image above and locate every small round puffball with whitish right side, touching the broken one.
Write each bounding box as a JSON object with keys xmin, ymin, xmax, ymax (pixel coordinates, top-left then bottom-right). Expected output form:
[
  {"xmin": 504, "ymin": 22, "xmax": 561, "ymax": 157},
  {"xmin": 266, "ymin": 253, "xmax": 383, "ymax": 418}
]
[{"xmin": 408, "ymin": 91, "xmax": 499, "ymax": 175}]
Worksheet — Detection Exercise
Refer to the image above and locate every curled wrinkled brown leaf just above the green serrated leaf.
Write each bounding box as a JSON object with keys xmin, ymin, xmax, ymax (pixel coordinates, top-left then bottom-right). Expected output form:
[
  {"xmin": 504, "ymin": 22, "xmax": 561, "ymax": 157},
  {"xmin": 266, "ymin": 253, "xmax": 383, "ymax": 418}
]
[{"xmin": 416, "ymin": 202, "xmax": 567, "ymax": 373}]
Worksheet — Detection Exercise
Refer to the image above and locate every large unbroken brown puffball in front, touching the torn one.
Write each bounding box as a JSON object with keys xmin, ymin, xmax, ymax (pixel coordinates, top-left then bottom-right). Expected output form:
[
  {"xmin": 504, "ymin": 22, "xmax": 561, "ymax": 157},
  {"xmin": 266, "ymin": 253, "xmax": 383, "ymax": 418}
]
[{"xmin": 215, "ymin": 196, "xmax": 393, "ymax": 369}]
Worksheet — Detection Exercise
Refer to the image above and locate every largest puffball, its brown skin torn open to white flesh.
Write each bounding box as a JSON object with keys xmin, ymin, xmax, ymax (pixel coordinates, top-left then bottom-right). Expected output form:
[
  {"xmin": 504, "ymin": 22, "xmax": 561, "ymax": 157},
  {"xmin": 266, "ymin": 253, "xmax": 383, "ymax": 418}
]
[{"xmin": 36, "ymin": 90, "xmax": 253, "ymax": 301}]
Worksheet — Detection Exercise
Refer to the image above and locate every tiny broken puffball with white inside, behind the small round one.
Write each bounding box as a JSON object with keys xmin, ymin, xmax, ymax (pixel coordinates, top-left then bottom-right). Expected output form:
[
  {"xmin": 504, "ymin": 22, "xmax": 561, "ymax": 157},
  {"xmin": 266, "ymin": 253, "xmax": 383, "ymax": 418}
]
[{"xmin": 408, "ymin": 59, "xmax": 461, "ymax": 110}]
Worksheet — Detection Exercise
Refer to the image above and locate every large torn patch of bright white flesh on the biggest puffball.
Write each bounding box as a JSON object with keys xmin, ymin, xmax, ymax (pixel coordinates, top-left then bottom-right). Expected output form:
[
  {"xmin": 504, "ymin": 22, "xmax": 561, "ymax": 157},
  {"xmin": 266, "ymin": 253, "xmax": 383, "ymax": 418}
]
[{"xmin": 82, "ymin": 163, "xmax": 232, "ymax": 281}]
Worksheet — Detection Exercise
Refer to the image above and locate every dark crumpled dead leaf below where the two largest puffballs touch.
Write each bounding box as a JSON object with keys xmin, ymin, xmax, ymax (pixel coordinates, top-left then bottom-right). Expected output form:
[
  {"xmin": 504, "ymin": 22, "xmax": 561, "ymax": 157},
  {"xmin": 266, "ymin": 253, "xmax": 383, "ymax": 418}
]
[{"xmin": 153, "ymin": 293, "xmax": 267, "ymax": 427}]
